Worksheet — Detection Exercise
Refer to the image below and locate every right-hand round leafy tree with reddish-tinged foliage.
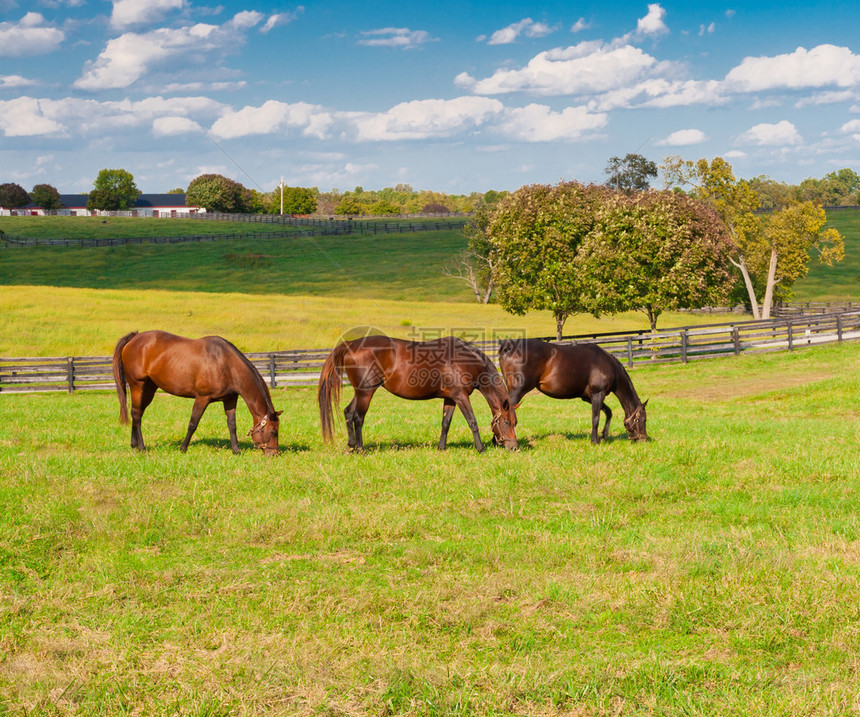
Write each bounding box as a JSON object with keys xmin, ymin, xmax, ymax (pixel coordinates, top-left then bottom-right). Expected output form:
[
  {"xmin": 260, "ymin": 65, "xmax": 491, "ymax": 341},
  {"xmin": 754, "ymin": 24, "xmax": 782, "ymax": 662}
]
[{"xmin": 579, "ymin": 192, "xmax": 733, "ymax": 331}]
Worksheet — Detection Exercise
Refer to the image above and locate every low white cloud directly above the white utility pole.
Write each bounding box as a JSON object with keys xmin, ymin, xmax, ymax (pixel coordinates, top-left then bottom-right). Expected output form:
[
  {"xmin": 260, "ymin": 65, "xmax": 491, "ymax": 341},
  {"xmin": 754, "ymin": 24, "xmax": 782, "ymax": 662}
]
[{"xmin": 210, "ymin": 100, "xmax": 332, "ymax": 139}]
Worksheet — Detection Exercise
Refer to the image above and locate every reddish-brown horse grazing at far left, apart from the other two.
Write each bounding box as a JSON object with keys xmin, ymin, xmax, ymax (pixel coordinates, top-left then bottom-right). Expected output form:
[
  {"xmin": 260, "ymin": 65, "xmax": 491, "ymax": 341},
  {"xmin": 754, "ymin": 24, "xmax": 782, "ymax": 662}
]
[{"xmin": 113, "ymin": 331, "xmax": 281, "ymax": 455}]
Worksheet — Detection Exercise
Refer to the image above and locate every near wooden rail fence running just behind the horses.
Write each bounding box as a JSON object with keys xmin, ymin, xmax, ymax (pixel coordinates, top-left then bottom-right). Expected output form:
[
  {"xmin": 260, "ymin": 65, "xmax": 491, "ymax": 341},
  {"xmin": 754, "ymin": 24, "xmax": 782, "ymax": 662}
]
[{"xmin": 0, "ymin": 310, "xmax": 860, "ymax": 393}]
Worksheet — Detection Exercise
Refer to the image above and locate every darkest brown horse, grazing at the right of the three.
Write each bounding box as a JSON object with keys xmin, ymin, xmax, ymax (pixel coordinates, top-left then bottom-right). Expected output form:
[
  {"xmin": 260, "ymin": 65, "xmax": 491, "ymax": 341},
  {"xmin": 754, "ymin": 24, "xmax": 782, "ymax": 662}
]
[{"xmin": 499, "ymin": 339, "xmax": 648, "ymax": 443}]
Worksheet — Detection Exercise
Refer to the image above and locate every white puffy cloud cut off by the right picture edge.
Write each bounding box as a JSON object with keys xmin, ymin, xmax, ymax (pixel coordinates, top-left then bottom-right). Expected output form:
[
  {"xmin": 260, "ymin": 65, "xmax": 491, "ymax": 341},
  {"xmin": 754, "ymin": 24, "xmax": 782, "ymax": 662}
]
[{"xmin": 726, "ymin": 45, "xmax": 860, "ymax": 92}]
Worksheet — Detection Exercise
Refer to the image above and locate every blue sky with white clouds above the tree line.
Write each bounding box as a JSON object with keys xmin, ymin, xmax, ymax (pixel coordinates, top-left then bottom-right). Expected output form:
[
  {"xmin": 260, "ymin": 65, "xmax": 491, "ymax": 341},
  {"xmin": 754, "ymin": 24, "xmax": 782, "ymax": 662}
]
[{"xmin": 0, "ymin": 0, "xmax": 860, "ymax": 193}]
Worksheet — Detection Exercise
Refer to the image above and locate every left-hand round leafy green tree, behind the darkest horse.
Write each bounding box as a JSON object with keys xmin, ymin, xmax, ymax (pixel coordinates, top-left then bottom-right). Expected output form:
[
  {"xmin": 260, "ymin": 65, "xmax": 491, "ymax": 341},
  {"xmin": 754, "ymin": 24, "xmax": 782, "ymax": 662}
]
[{"xmin": 486, "ymin": 182, "xmax": 611, "ymax": 338}]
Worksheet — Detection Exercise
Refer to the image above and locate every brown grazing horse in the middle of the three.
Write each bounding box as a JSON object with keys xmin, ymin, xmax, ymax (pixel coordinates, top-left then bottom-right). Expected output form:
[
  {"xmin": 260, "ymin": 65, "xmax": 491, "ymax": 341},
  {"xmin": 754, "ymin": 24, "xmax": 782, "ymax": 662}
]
[{"xmin": 317, "ymin": 336, "xmax": 517, "ymax": 451}]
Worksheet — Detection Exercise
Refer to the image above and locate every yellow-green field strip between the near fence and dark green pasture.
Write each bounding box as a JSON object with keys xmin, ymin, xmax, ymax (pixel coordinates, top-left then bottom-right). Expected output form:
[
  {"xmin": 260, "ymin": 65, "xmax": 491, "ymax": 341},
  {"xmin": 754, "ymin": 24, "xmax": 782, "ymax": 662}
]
[{"xmin": 0, "ymin": 286, "xmax": 743, "ymax": 357}]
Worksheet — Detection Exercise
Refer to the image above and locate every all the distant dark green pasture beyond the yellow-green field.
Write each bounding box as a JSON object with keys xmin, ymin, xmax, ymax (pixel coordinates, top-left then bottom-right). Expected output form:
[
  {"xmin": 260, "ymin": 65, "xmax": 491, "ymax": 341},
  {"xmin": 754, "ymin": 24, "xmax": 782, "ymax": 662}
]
[{"xmin": 0, "ymin": 210, "xmax": 860, "ymax": 302}]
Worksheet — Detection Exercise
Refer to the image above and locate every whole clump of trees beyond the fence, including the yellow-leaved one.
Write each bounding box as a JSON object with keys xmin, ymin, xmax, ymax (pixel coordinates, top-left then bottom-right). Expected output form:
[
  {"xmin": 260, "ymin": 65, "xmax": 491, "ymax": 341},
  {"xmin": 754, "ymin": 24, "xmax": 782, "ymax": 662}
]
[{"xmin": 456, "ymin": 157, "xmax": 844, "ymax": 338}]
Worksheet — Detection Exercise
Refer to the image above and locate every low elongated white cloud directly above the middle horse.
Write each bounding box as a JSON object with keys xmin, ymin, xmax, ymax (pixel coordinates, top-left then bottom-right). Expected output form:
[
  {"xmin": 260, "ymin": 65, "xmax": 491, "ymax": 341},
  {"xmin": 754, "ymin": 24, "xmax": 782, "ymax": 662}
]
[{"xmin": 353, "ymin": 97, "xmax": 504, "ymax": 141}]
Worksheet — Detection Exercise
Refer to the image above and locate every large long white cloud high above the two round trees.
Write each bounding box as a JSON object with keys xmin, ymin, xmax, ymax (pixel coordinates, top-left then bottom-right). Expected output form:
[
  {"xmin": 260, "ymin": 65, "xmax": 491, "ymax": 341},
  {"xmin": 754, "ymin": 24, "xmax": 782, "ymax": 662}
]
[{"xmin": 454, "ymin": 41, "xmax": 657, "ymax": 95}]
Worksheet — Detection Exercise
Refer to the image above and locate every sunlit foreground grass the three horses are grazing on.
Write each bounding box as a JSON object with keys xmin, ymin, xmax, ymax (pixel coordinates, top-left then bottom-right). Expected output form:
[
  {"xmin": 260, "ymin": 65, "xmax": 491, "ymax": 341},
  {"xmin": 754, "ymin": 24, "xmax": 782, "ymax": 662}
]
[{"xmin": 0, "ymin": 343, "xmax": 860, "ymax": 715}]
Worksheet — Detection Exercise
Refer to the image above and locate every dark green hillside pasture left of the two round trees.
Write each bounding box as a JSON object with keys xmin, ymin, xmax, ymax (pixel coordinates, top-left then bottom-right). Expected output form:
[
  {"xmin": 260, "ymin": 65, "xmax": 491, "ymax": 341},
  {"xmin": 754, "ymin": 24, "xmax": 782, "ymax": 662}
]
[{"xmin": 0, "ymin": 227, "xmax": 470, "ymax": 301}]
